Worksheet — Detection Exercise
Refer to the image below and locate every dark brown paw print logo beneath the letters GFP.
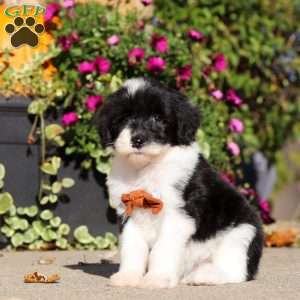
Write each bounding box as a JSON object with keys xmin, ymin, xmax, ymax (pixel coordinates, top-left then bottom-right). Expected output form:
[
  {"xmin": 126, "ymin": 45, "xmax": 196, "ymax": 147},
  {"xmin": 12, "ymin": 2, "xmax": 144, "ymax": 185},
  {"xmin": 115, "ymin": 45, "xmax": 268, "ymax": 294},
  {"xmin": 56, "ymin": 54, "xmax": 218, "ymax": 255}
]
[{"xmin": 5, "ymin": 17, "xmax": 45, "ymax": 48}]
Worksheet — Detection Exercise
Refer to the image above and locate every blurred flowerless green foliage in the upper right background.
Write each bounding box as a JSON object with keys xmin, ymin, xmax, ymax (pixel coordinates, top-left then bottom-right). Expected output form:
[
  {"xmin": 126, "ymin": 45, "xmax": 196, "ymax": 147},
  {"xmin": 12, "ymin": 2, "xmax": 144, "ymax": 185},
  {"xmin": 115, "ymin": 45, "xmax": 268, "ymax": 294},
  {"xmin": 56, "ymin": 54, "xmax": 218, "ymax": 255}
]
[{"xmin": 155, "ymin": 0, "xmax": 300, "ymax": 162}]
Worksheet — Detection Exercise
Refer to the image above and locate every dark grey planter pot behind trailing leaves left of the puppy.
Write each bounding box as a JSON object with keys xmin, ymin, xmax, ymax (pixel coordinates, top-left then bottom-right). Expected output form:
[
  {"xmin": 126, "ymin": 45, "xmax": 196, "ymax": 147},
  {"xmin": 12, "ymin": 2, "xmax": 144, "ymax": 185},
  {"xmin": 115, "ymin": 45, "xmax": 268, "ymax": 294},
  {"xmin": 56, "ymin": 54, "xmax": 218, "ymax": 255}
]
[{"xmin": 0, "ymin": 96, "xmax": 117, "ymax": 243}]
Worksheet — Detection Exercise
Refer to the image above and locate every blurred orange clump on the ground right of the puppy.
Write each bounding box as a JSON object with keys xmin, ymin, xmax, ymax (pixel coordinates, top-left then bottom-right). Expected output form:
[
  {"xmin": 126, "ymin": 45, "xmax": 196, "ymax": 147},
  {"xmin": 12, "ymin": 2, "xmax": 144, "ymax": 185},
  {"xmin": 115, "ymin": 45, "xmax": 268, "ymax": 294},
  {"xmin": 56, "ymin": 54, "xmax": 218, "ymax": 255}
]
[{"xmin": 265, "ymin": 229, "xmax": 297, "ymax": 247}]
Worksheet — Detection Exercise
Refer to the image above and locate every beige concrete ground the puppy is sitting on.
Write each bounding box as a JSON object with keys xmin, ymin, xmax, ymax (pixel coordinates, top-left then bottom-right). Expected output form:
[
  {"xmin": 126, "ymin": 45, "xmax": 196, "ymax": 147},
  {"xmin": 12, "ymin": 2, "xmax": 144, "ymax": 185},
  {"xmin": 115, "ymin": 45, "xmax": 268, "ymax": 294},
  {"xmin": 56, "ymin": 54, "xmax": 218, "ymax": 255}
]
[{"xmin": 0, "ymin": 248, "xmax": 300, "ymax": 300}]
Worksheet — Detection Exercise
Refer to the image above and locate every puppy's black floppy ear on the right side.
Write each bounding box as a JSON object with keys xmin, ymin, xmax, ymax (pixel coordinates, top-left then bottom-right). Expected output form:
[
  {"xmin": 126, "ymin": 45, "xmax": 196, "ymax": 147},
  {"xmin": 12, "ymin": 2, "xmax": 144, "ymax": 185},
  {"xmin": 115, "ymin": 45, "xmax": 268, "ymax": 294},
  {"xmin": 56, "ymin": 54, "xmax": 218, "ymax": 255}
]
[{"xmin": 173, "ymin": 93, "xmax": 200, "ymax": 145}]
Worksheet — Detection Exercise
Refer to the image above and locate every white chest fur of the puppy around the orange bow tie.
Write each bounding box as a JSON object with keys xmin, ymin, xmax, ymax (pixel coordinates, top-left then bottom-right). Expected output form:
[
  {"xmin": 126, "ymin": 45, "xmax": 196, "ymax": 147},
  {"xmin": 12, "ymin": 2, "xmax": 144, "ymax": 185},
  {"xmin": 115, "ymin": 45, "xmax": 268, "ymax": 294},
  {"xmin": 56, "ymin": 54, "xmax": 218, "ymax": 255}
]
[{"xmin": 107, "ymin": 144, "xmax": 199, "ymax": 244}]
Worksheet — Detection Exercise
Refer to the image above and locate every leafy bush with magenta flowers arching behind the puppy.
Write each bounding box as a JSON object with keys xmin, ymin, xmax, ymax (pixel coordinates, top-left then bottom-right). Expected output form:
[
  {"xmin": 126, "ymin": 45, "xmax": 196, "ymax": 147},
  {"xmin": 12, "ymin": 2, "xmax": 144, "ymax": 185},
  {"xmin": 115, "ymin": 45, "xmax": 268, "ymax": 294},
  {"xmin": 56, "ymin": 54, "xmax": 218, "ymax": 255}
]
[{"xmin": 1, "ymin": 0, "xmax": 300, "ymax": 230}]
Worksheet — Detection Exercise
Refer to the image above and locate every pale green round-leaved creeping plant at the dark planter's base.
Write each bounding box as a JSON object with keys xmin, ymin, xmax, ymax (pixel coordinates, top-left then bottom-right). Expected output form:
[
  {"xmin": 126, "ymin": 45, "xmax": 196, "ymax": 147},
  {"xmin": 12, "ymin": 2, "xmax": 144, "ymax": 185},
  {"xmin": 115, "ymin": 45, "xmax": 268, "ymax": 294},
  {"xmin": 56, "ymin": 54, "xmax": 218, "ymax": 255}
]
[{"xmin": 0, "ymin": 159, "xmax": 117, "ymax": 250}]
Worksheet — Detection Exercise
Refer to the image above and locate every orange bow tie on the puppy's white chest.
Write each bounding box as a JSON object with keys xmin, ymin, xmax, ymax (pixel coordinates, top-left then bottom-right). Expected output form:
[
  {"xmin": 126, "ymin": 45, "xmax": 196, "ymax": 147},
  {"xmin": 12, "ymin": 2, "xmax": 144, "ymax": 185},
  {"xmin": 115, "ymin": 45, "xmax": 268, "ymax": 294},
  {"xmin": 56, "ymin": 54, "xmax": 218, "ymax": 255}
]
[{"xmin": 122, "ymin": 190, "xmax": 163, "ymax": 216}]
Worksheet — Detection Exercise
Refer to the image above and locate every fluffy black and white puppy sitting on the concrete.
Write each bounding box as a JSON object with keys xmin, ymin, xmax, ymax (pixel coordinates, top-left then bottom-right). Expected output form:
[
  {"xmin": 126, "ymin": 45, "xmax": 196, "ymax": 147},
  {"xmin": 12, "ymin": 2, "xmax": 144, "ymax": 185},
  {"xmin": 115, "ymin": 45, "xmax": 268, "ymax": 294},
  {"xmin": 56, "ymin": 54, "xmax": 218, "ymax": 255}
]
[{"xmin": 96, "ymin": 78, "xmax": 263, "ymax": 288}]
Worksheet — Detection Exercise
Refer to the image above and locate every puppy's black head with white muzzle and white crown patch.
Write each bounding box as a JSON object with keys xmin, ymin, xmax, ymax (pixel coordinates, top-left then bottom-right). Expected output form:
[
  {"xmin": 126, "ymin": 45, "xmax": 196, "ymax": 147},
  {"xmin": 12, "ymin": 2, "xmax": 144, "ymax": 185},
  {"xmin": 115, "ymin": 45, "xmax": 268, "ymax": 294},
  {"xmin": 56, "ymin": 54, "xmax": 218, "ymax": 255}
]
[{"xmin": 96, "ymin": 78, "xmax": 199, "ymax": 166}]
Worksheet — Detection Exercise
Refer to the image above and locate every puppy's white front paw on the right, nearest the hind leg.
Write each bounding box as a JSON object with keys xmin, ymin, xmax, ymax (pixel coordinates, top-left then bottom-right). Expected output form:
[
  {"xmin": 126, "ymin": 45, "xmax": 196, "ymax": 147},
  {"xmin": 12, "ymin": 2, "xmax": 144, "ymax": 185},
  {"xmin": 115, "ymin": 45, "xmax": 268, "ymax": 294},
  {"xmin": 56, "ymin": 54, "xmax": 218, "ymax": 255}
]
[{"xmin": 139, "ymin": 273, "xmax": 178, "ymax": 289}]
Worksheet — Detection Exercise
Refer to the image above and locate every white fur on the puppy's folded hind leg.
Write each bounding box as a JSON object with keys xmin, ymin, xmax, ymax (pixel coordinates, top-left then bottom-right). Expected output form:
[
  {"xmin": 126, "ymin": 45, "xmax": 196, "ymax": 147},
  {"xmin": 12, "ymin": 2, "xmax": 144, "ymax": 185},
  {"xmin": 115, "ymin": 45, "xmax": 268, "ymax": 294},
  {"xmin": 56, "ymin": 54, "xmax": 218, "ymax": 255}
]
[{"xmin": 182, "ymin": 224, "xmax": 256, "ymax": 285}]
